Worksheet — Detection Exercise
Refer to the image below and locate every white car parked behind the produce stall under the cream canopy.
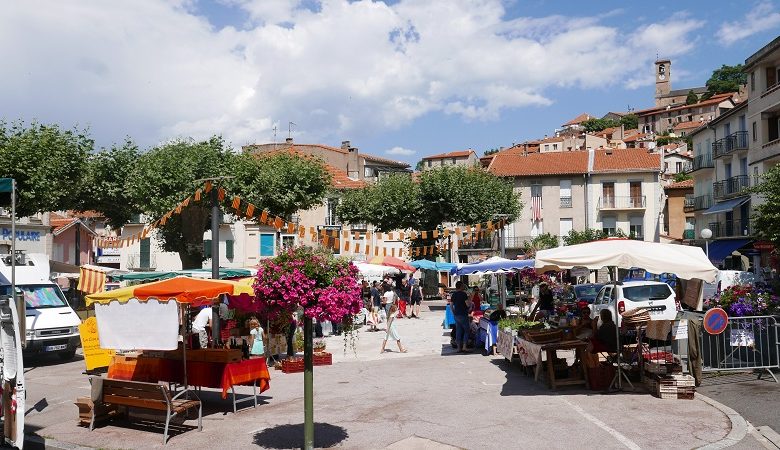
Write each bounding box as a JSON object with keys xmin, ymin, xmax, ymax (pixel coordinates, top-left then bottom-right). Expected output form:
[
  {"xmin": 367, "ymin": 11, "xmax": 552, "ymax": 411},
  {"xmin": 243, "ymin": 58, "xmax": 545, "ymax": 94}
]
[{"xmin": 590, "ymin": 281, "xmax": 678, "ymax": 326}]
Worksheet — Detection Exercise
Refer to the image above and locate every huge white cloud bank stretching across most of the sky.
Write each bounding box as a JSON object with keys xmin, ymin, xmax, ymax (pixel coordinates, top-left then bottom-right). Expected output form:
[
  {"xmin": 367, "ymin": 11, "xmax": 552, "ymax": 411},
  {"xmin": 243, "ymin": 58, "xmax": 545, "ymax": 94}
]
[{"xmin": 0, "ymin": 0, "xmax": 703, "ymax": 149}]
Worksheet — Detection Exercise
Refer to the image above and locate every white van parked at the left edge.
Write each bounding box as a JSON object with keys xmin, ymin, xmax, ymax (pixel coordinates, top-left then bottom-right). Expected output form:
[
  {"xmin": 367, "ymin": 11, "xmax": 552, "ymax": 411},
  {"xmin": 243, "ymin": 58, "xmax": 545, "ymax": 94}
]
[{"xmin": 0, "ymin": 253, "xmax": 81, "ymax": 360}]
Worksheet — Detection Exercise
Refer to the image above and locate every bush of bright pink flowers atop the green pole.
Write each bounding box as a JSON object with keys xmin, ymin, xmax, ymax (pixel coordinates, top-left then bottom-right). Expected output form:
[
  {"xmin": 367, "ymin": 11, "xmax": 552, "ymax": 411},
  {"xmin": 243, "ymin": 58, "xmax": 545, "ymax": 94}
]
[{"xmin": 253, "ymin": 247, "xmax": 363, "ymax": 323}]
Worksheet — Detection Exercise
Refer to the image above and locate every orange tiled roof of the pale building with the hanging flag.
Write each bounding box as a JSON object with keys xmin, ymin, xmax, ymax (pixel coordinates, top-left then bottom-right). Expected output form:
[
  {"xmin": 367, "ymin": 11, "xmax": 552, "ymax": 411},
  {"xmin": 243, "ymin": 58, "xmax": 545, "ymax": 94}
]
[{"xmin": 488, "ymin": 151, "xmax": 588, "ymax": 177}]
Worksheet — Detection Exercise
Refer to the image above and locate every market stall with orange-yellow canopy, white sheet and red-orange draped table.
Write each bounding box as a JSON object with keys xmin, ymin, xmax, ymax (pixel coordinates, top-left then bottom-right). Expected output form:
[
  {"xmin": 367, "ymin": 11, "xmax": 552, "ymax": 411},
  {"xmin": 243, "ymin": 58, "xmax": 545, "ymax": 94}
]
[{"xmin": 86, "ymin": 277, "xmax": 270, "ymax": 411}]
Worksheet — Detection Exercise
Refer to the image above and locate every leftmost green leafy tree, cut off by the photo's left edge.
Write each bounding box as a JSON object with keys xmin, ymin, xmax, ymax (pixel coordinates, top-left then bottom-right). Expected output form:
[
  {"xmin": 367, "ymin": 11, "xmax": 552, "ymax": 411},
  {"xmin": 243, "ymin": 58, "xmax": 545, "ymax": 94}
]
[{"xmin": 0, "ymin": 121, "xmax": 94, "ymax": 217}]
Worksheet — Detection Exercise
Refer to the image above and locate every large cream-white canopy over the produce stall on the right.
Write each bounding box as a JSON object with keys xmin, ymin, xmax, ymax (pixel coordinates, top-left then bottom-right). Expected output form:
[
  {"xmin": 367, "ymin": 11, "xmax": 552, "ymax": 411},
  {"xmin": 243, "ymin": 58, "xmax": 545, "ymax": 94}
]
[{"xmin": 535, "ymin": 239, "xmax": 718, "ymax": 283}]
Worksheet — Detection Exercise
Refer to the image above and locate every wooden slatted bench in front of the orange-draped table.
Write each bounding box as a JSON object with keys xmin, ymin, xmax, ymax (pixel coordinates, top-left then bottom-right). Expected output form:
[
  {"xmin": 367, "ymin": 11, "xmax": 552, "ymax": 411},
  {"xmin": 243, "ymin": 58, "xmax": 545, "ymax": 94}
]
[{"xmin": 89, "ymin": 377, "xmax": 203, "ymax": 445}]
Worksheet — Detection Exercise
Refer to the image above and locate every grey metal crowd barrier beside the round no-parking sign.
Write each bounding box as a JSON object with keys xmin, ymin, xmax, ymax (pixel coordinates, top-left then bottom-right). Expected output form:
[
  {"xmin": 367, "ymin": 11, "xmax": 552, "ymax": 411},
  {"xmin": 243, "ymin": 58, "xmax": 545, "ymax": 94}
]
[{"xmin": 701, "ymin": 316, "xmax": 780, "ymax": 382}]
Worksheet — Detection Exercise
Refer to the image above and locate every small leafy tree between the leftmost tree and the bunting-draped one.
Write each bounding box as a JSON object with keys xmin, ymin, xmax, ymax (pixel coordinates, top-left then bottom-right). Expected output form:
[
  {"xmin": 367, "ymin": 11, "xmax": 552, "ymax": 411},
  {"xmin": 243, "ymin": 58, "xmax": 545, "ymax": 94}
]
[{"xmin": 78, "ymin": 138, "xmax": 140, "ymax": 229}]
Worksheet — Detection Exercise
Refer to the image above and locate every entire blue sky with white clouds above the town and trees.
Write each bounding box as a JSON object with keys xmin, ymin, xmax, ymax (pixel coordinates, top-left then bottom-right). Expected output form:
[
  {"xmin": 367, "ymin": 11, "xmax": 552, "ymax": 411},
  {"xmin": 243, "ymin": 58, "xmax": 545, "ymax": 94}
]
[{"xmin": 0, "ymin": 0, "xmax": 780, "ymax": 165}]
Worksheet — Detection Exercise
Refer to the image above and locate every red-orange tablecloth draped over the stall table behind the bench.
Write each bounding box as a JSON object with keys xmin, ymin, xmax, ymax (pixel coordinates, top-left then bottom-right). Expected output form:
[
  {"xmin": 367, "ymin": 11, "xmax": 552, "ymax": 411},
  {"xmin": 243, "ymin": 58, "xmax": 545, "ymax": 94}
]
[{"xmin": 108, "ymin": 357, "xmax": 271, "ymax": 398}]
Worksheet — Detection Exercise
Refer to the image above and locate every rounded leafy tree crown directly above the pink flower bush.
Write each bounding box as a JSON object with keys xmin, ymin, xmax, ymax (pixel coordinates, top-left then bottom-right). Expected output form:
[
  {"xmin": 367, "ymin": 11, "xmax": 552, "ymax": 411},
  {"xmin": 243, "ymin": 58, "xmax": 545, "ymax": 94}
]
[{"xmin": 226, "ymin": 153, "xmax": 331, "ymax": 219}]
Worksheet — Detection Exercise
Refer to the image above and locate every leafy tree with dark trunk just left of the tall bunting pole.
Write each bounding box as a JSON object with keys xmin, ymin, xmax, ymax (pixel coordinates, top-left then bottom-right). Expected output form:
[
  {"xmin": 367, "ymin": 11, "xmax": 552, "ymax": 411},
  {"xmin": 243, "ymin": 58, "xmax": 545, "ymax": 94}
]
[{"xmin": 127, "ymin": 136, "xmax": 235, "ymax": 269}]
